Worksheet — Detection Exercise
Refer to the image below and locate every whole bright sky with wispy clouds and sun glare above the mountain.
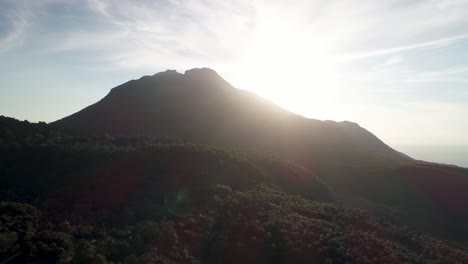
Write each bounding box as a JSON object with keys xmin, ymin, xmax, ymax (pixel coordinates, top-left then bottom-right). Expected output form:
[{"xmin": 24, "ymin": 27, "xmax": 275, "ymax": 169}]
[{"xmin": 0, "ymin": 0, "xmax": 468, "ymax": 145}]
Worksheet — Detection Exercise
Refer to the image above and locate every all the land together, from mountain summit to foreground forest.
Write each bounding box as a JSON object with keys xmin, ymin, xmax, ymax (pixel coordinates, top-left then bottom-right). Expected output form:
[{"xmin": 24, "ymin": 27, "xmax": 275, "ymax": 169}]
[{"xmin": 0, "ymin": 69, "xmax": 468, "ymax": 264}]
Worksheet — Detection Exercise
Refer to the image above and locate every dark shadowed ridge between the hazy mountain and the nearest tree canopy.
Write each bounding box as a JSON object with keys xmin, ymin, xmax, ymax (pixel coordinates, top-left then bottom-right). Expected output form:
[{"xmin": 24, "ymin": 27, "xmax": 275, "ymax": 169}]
[{"xmin": 0, "ymin": 117, "xmax": 332, "ymax": 214}]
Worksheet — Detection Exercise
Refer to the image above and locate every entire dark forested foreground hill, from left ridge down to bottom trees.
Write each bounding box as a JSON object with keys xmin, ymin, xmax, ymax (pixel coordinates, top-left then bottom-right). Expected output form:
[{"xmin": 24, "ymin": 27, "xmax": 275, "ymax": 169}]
[{"xmin": 0, "ymin": 117, "xmax": 468, "ymax": 264}]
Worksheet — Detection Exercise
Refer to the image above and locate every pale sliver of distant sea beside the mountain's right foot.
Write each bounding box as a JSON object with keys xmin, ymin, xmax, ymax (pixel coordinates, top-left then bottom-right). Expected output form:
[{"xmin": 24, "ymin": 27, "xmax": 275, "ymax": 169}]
[{"xmin": 392, "ymin": 144, "xmax": 468, "ymax": 168}]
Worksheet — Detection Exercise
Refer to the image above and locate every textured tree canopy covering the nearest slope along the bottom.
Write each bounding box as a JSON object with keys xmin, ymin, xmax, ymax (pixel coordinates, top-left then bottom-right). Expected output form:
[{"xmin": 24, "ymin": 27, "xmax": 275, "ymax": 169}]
[{"xmin": 0, "ymin": 185, "xmax": 468, "ymax": 264}]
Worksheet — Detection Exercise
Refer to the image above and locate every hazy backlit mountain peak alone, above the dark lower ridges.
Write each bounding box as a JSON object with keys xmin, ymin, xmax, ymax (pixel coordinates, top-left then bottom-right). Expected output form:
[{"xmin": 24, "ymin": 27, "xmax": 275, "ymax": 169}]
[{"xmin": 56, "ymin": 68, "xmax": 411, "ymax": 166}]
